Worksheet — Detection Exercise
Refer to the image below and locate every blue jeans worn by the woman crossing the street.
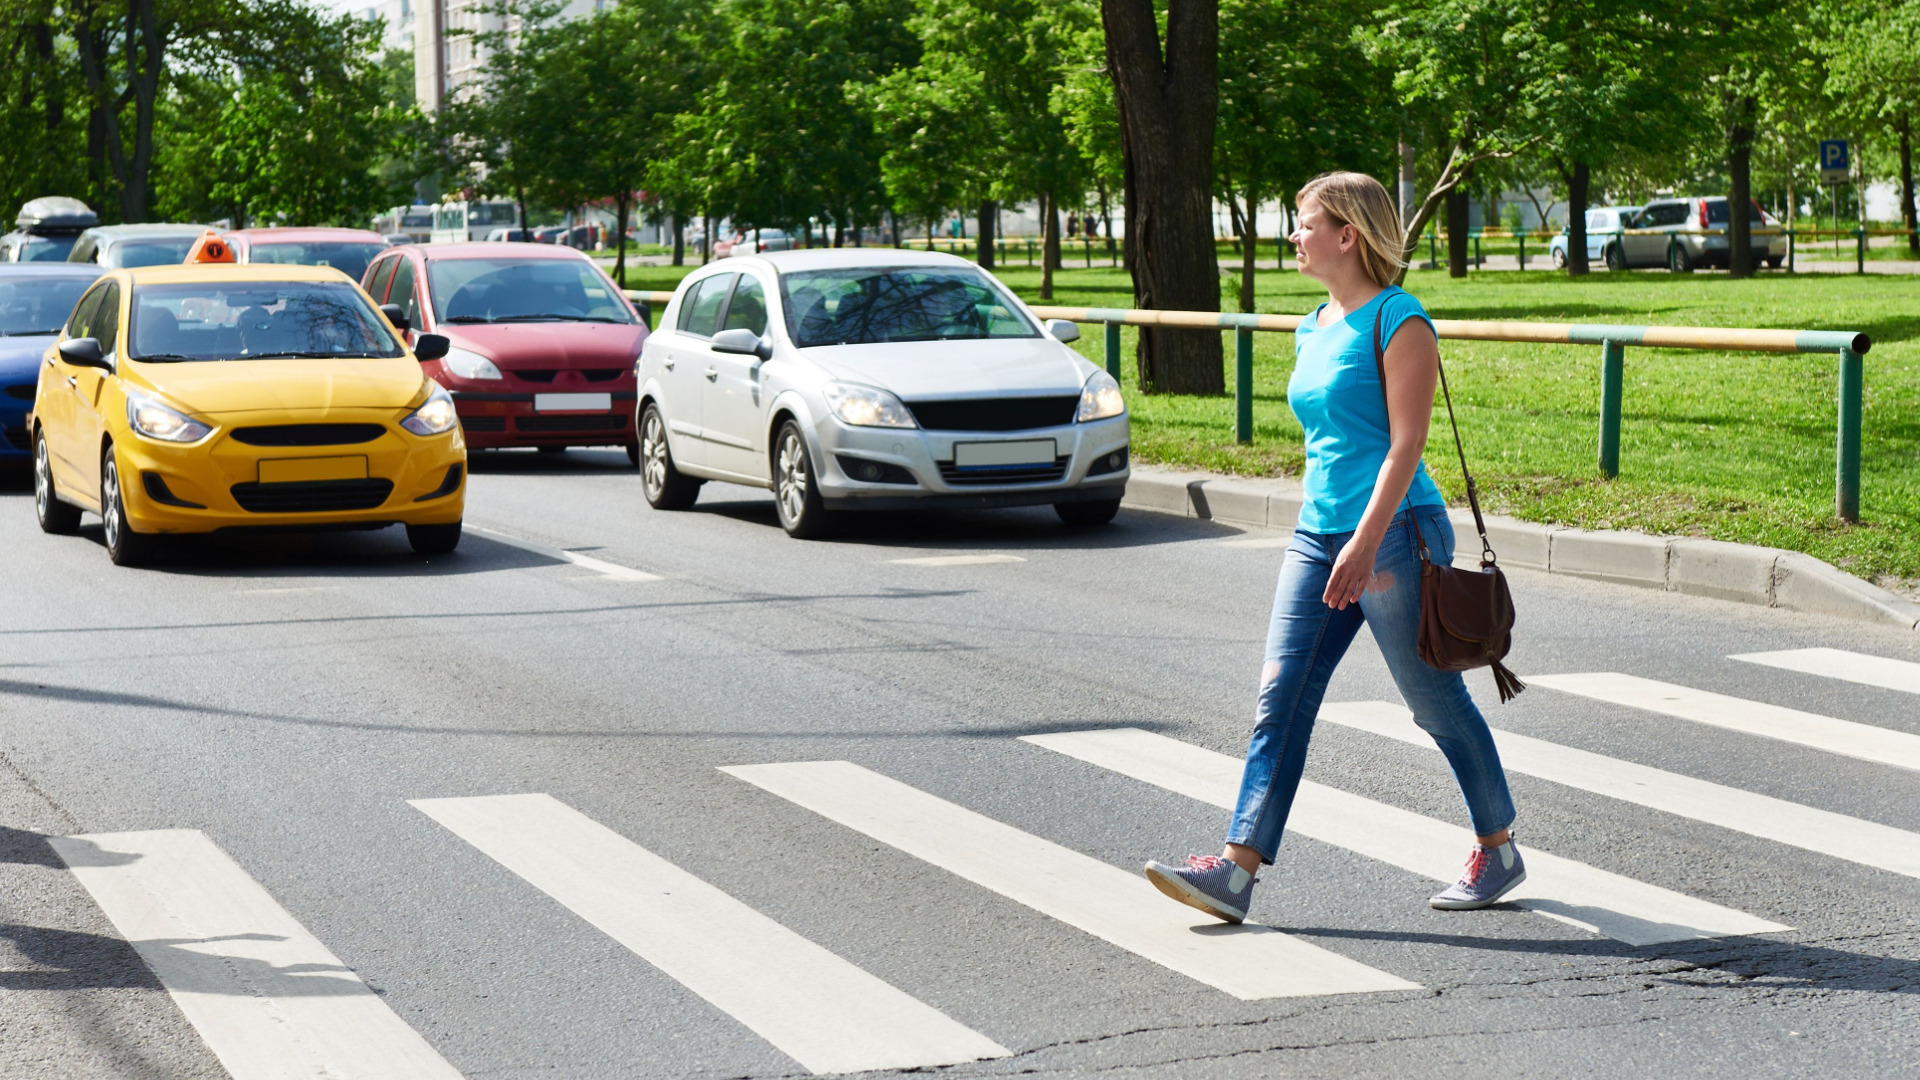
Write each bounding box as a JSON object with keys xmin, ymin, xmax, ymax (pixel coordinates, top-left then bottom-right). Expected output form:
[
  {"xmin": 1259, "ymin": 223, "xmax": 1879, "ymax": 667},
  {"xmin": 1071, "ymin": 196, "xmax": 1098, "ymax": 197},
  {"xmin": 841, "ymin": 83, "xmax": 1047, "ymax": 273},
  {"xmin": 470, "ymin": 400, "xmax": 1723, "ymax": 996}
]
[{"xmin": 1227, "ymin": 505, "xmax": 1513, "ymax": 863}]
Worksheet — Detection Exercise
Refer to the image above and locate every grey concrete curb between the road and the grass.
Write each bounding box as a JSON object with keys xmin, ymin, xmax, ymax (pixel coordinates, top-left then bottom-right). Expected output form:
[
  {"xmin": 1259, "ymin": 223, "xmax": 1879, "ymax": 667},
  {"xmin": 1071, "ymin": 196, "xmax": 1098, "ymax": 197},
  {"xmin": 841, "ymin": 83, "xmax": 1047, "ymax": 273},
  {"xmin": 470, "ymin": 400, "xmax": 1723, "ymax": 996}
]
[{"xmin": 1123, "ymin": 467, "xmax": 1920, "ymax": 630}]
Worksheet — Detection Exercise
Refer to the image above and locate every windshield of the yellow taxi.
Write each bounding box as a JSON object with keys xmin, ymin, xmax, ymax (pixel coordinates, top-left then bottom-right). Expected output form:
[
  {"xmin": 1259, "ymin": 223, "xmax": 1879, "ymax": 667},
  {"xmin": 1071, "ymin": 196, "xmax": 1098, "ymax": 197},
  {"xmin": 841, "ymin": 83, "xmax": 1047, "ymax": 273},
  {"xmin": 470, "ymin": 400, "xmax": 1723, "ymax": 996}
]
[{"xmin": 129, "ymin": 281, "xmax": 403, "ymax": 363}]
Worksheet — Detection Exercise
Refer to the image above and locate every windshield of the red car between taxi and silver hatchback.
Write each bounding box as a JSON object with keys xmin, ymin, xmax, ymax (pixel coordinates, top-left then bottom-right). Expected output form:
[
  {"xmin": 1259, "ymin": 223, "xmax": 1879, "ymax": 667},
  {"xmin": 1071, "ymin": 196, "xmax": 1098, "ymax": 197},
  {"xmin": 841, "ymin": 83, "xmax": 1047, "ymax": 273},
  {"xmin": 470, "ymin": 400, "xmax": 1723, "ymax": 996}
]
[{"xmin": 426, "ymin": 259, "xmax": 634, "ymax": 323}]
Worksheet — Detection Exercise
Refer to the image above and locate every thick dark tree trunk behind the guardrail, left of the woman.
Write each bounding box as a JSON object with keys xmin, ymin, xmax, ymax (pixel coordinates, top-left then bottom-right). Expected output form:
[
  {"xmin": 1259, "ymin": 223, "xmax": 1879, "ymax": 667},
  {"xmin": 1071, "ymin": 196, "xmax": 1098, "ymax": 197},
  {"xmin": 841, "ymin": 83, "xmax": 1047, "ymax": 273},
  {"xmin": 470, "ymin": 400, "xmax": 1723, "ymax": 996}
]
[{"xmin": 1100, "ymin": 0, "xmax": 1227, "ymax": 394}]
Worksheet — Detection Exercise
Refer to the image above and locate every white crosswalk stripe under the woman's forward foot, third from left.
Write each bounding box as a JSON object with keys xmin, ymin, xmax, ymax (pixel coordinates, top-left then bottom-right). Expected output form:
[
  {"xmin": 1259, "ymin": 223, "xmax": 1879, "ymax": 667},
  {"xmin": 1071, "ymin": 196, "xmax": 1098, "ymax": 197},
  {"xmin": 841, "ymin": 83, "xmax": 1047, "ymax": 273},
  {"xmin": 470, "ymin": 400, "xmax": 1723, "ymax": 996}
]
[{"xmin": 720, "ymin": 761, "xmax": 1419, "ymax": 1001}]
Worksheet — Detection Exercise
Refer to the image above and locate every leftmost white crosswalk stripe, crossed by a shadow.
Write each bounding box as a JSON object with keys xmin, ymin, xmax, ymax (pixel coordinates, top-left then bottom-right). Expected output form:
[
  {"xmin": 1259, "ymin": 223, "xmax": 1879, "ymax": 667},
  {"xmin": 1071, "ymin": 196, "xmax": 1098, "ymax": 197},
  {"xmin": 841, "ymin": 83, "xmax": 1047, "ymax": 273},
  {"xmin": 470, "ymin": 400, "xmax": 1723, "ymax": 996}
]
[{"xmin": 48, "ymin": 828, "xmax": 461, "ymax": 1080}]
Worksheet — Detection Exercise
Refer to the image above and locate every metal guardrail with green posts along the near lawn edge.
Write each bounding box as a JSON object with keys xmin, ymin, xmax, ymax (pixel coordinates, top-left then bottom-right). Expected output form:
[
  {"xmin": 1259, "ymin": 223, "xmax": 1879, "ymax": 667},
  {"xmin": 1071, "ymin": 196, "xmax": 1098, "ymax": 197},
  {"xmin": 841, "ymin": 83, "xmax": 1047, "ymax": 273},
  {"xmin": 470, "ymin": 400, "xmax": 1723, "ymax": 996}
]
[{"xmin": 626, "ymin": 290, "xmax": 1874, "ymax": 523}]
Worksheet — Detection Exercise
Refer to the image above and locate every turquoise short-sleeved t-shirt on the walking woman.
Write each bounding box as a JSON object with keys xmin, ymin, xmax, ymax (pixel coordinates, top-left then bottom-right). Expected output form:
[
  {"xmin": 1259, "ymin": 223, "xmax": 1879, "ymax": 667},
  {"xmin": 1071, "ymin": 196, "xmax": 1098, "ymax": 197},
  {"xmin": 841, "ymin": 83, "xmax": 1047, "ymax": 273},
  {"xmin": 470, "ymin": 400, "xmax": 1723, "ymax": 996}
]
[{"xmin": 1286, "ymin": 284, "xmax": 1446, "ymax": 532}]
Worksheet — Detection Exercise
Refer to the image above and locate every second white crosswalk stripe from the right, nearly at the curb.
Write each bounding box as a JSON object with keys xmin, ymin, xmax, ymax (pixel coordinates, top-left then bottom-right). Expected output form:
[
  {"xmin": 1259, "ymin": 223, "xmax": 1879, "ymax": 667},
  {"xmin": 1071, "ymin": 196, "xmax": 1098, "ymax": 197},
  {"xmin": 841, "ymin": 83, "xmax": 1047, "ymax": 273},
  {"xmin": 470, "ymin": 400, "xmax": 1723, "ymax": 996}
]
[{"xmin": 1526, "ymin": 671, "xmax": 1920, "ymax": 769}]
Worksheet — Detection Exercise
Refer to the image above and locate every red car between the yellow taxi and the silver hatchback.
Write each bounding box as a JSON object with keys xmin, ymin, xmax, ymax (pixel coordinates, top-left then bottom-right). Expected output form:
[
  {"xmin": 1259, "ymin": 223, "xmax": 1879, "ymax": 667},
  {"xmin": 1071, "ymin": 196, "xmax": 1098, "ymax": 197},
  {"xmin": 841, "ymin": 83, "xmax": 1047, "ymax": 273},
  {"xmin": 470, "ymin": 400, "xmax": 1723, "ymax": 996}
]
[{"xmin": 361, "ymin": 242, "xmax": 647, "ymax": 455}]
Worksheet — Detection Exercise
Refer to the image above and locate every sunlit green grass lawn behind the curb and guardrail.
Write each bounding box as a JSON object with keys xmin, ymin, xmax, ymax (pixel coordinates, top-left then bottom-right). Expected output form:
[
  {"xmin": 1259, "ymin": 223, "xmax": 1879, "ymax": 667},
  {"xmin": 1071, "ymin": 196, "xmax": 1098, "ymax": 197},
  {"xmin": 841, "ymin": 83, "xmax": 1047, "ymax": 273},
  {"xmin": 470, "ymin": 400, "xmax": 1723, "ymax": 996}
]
[{"xmin": 628, "ymin": 263, "xmax": 1920, "ymax": 584}]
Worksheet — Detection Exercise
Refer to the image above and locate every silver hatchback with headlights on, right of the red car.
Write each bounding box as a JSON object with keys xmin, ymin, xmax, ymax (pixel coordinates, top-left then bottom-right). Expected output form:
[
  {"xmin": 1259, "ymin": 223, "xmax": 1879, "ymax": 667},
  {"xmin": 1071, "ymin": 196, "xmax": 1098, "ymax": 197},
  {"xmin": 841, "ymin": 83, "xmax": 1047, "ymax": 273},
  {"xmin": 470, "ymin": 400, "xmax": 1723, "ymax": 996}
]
[{"xmin": 636, "ymin": 248, "xmax": 1129, "ymax": 538}]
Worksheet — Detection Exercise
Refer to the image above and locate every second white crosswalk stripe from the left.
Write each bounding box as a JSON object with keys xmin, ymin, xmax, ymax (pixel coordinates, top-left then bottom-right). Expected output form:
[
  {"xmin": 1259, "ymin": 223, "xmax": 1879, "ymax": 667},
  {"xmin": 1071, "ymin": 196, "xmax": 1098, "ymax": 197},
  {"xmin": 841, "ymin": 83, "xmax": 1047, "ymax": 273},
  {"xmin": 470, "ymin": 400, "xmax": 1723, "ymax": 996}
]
[{"xmin": 411, "ymin": 796, "xmax": 1012, "ymax": 1072}]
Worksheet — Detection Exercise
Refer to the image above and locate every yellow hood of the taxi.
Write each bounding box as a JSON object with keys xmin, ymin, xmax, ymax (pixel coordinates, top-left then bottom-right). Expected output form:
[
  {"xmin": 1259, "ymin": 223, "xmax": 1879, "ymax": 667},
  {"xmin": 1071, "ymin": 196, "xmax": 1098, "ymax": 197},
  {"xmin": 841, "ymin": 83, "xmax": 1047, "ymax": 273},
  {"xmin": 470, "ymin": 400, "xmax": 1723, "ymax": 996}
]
[{"xmin": 123, "ymin": 356, "xmax": 426, "ymax": 415}]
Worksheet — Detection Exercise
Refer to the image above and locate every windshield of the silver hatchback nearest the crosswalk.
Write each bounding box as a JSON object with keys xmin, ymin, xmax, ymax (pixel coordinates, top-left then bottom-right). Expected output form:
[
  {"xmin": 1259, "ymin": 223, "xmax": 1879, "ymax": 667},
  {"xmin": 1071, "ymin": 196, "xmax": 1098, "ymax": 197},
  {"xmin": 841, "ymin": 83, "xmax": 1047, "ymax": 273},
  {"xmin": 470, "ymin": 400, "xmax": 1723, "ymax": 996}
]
[{"xmin": 780, "ymin": 267, "xmax": 1041, "ymax": 348}]
